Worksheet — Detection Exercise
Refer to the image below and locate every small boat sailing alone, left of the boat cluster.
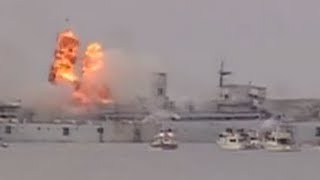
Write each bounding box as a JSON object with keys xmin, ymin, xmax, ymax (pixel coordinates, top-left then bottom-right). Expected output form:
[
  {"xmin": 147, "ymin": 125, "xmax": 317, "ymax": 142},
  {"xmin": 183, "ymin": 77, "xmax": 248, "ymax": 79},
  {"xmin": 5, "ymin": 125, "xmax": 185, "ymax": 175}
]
[{"xmin": 150, "ymin": 129, "xmax": 178, "ymax": 150}]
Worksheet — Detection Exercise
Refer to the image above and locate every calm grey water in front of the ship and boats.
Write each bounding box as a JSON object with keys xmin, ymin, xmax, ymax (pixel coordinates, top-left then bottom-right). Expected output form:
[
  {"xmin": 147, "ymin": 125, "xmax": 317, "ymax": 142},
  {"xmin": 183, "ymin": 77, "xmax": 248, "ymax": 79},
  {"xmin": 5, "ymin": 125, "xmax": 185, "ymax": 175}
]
[{"xmin": 0, "ymin": 143, "xmax": 320, "ymax": 180}]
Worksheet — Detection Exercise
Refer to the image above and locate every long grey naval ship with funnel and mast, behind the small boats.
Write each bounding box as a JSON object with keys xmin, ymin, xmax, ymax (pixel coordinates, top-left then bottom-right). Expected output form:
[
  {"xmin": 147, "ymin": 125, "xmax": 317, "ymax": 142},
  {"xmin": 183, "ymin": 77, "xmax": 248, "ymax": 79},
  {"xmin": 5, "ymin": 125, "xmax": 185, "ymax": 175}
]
[{"xmin": 0, "ymin": 63, "xmax": 320, "ymax": 143}]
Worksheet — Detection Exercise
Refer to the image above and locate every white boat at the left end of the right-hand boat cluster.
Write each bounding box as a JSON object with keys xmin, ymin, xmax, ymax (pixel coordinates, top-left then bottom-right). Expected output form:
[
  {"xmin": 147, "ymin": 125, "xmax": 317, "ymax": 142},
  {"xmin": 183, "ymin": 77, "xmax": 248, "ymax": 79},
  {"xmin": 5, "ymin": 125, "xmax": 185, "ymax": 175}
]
[{"xmin": 217, "ymin": 128, "xmax": 250, "ymax": 150}]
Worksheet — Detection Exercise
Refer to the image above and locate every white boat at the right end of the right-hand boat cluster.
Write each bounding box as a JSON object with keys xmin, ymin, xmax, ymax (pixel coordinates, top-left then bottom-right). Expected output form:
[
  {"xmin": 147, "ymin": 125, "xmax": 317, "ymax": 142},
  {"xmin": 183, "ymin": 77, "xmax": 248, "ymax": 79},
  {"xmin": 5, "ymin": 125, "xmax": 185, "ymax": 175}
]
[{"xmin": 263, "ymin": 126, "xmax": 298, "ymax": 152}]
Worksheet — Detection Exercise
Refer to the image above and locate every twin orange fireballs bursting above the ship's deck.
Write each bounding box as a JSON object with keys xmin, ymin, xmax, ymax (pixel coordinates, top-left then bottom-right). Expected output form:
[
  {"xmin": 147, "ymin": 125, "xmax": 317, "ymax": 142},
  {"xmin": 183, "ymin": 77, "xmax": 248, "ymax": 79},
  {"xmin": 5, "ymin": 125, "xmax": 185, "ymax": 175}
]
[{"xmin": 49, "ymin": 30, "xmax": 112, "ymax": 104}]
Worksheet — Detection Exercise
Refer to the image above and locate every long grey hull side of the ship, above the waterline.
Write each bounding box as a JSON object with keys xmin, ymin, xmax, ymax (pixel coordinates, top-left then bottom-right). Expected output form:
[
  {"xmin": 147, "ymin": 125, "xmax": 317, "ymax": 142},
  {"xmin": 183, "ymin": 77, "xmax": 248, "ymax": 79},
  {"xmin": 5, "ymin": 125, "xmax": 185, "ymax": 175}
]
[{"xmin": 0, "ymin": 120, "xmax": 320, "ymax": 143}]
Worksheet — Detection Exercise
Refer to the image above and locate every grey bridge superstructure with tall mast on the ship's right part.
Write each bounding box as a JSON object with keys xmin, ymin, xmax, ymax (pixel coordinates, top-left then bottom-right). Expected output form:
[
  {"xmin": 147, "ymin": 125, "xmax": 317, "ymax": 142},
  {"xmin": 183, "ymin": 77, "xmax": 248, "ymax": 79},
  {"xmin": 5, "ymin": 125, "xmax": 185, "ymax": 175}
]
[{"xmin": 171, "ymin": 62, "xmax": 270, "ymax": 121}]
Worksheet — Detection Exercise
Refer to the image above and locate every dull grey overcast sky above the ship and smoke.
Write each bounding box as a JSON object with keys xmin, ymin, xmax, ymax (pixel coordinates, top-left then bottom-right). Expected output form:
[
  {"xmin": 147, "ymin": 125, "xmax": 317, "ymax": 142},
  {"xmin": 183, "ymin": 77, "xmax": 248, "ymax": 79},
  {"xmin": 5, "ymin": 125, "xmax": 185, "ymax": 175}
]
[{"xmin": 0, "ymin": 0, "xmax": 320, "ymax": 101}]
